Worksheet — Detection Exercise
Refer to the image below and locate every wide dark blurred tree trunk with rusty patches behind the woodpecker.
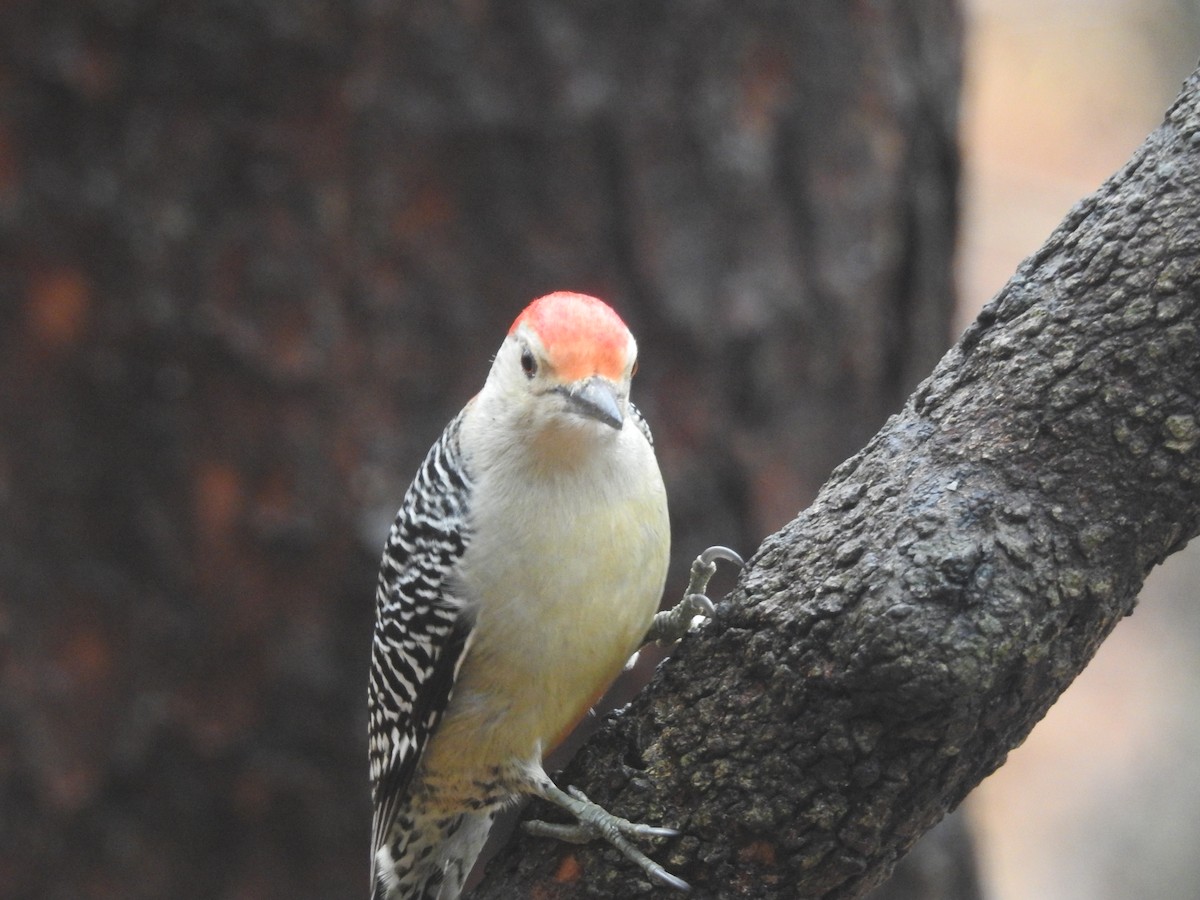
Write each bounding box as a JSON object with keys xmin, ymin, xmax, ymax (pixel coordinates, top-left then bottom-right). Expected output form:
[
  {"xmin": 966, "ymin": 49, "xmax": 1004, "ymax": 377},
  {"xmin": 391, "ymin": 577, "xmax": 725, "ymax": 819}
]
[{"xmin": 0, "ymin": 0, "xmax": 960, "ymax": 898}]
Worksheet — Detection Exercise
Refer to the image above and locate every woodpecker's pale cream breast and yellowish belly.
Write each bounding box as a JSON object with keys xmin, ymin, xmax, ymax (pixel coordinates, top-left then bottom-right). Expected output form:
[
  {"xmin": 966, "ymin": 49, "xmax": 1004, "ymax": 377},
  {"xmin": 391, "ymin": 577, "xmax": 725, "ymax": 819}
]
[{"xmin": 431, "ymin": 436, "xmax": 670, "ymax": 787}]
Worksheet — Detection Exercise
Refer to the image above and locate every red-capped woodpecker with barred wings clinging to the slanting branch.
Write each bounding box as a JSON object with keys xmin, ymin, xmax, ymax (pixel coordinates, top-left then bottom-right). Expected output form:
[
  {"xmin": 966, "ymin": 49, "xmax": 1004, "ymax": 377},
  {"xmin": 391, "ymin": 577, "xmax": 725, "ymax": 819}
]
[{"xmin": 368, "ymin": 293, "xmax": 740, "ymax": 900}]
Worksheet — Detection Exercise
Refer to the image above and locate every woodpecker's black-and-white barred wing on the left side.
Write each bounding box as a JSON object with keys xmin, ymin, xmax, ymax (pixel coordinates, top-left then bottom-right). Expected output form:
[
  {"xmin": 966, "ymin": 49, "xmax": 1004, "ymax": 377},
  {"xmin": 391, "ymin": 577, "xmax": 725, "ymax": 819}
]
[{"xmin": 367, "ymin": 413, "xmax": 470, "ymax": 854}]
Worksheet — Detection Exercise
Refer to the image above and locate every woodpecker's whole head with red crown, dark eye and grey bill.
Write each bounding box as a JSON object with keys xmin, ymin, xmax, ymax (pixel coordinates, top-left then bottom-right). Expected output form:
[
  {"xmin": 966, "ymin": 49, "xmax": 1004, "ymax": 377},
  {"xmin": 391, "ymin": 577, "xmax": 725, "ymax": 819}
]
[{"xmin": 488, "ymin": 292, "xmax": 637, "ymax": 433}]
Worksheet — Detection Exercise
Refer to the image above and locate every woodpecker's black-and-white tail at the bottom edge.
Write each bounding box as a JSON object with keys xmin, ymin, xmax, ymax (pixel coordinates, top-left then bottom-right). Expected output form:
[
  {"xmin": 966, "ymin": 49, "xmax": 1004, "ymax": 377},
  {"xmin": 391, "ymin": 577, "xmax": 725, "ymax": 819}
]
[{"xmin": 371, "ymin": 809, "xmax": 496, "ymax": 900}]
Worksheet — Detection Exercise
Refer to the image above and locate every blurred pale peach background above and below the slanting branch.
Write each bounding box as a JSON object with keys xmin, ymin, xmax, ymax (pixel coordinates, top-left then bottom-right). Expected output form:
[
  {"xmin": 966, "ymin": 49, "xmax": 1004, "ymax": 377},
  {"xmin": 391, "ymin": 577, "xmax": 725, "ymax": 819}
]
[{"xmin": 959, "ymin": 0, "xmax": 1200, "ymax": 900}]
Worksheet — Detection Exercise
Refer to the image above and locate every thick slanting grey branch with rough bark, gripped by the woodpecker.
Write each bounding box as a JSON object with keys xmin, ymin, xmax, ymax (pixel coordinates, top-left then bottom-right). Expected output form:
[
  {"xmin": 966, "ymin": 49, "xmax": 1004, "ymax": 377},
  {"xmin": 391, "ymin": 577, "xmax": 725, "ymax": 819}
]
[{"xmin": 479, "ymin": 65, "xmax": 1200, "ymax": 900}]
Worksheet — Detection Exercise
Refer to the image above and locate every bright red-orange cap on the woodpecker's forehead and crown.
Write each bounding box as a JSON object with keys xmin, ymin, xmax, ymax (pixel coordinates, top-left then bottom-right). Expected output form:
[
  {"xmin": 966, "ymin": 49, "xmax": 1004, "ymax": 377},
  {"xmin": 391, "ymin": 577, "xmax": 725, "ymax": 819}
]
[{"xmin": 509, "ymin": 290, "xmax": 632, "ymax": 382}]
